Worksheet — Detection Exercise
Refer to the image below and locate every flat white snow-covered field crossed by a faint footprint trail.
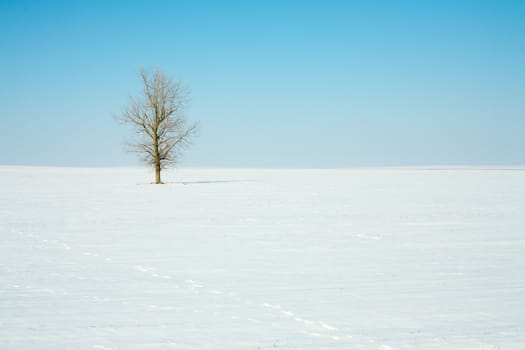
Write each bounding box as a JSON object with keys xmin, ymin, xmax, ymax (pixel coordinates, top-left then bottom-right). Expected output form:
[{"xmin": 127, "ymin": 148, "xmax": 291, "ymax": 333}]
[{"xmin": 0, "ymin": 167, "xmax": 525, "ymax": 350}]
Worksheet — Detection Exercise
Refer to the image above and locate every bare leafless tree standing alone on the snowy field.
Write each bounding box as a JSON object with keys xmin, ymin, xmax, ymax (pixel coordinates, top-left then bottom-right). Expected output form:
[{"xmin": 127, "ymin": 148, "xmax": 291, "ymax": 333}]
[{"xmin": 121, "ymin": 69, "xmax": 198, "ymax": 184}]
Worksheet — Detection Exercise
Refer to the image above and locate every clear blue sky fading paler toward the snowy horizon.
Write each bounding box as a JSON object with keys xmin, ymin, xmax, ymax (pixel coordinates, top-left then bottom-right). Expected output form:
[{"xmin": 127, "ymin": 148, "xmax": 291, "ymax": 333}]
[{"xmin": 0, "ymin": 0, "xmax": 525, "ymax": 167}]
